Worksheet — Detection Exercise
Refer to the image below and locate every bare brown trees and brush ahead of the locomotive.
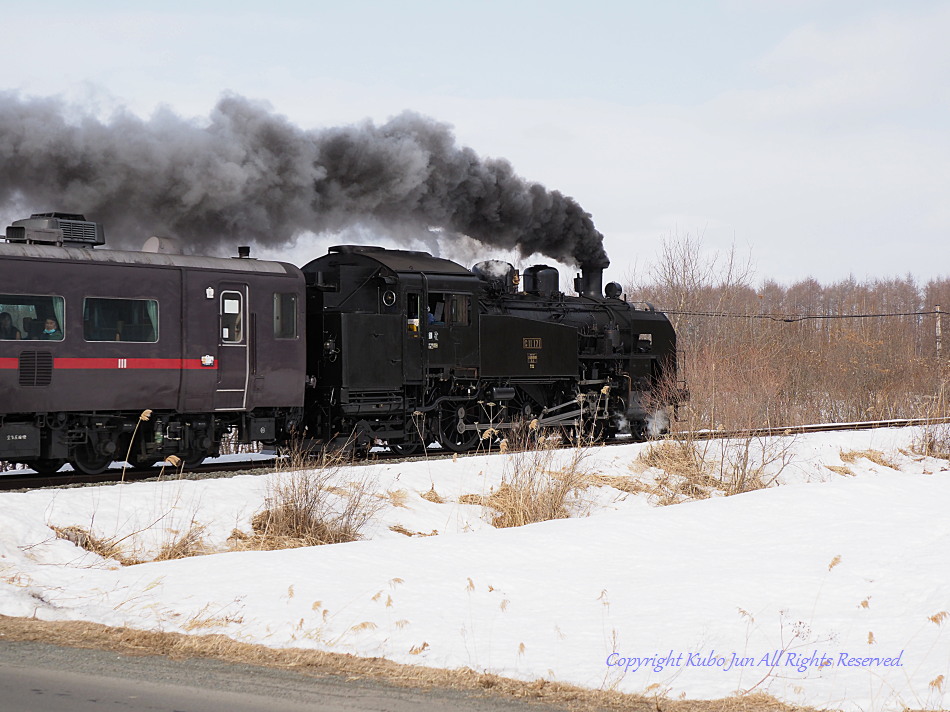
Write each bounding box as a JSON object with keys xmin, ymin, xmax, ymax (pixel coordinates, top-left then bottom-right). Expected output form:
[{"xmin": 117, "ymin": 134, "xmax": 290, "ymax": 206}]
[{"xmin": 626, "ymin": 236, "xmax": 950, "ymax": 429}]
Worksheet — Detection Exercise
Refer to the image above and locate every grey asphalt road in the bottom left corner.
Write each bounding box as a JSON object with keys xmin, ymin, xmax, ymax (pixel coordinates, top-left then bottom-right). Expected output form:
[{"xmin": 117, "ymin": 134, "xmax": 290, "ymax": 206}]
[{"xmin": 0, "ymin": 642, "xmax": 561, "ymax": 712}]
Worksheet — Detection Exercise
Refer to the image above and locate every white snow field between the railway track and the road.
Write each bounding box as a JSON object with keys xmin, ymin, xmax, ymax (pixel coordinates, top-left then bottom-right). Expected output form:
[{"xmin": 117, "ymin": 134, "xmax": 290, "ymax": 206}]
[{"xmin": 0, "ymin": 428, "xmax": 950, "ymax": 710}]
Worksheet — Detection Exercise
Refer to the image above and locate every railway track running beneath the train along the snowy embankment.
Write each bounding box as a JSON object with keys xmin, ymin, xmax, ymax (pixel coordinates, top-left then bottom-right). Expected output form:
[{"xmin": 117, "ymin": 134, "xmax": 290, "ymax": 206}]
[{"xmin": 0, "ymin": 417, "xmax": 950, "ymax": 491}]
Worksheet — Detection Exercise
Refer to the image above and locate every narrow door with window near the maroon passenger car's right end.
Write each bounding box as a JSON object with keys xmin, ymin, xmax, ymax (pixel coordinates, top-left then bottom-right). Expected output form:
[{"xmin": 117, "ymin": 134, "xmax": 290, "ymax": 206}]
[{"xmin": 214, "ymin": 284, "xmax": 252, "ymax": 410}]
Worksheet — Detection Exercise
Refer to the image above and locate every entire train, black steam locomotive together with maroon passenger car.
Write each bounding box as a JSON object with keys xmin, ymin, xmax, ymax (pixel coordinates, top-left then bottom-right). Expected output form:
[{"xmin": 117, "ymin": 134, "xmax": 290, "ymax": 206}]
[{"xmin": 0, "ymin": 213, "xmax": 684, "ymax": 474}]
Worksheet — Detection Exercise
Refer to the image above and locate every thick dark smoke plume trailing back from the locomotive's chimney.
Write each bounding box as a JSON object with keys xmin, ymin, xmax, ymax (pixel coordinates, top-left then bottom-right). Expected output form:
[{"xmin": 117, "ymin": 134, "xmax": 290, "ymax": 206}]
[{"xmin": 0, "ymin": 94, "xmax": 609, "ymax": 267}]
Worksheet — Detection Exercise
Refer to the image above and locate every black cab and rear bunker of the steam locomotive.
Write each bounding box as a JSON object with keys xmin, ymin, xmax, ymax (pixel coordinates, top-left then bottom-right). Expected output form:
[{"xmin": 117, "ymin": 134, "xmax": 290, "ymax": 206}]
[{"xmin": 303, "ymin": 245, "xmax": 479, "ymax": 451}]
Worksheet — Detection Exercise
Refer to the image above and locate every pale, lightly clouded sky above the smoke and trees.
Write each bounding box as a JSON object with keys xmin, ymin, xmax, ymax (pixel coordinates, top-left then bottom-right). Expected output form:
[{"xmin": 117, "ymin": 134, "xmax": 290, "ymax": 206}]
[{"xmin": 0, "ymin": 0, "xmax": 950, "ymax": 283}]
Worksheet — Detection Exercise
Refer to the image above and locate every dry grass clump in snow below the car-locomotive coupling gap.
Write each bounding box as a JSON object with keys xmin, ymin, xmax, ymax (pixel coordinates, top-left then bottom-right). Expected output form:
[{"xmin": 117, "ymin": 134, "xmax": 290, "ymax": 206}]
[{"xmin": 228, "ymin": 465, "xmax": 388, "ymax": 551}]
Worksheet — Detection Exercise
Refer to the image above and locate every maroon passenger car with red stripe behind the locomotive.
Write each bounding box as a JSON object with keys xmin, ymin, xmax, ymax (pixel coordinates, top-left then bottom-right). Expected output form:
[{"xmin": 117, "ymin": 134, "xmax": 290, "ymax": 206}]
[{"xmin": 0, "ymin": 213, "xmax": 306, "ymax": 473}]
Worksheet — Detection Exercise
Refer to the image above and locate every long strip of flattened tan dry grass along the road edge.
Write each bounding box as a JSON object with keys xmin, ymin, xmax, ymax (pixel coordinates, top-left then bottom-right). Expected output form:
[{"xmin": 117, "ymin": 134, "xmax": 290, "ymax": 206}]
[{"xmin": 0, "ymin": 615, "xmax": 817, "ymax": 712}]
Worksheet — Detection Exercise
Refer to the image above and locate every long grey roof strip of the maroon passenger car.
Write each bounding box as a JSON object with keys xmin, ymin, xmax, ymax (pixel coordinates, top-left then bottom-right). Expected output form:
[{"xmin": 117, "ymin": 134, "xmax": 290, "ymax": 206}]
[{"xmin": 0, "ymin": 242, "xmax": 297, "ymax": 274}]
